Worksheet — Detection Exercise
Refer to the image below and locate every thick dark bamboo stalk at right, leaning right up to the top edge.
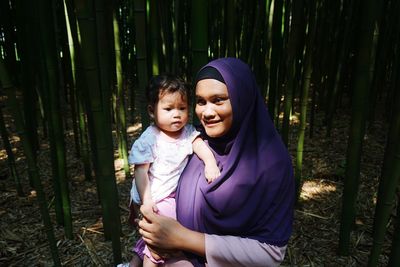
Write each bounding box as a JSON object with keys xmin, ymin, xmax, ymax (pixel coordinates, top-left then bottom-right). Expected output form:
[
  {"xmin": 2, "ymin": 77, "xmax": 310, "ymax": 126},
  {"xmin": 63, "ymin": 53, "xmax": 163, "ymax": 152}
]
[{"xmin": 339, "ymin": 0, "xmax": 376, "ymax": 255}]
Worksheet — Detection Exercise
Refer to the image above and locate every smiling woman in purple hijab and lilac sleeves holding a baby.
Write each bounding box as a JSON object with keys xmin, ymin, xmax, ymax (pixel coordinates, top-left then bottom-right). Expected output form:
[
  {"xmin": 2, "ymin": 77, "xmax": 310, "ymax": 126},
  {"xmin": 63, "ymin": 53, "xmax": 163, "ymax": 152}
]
[{"xmin": 139, "ymin": 58, "xmax": 294, "ymax": 266}]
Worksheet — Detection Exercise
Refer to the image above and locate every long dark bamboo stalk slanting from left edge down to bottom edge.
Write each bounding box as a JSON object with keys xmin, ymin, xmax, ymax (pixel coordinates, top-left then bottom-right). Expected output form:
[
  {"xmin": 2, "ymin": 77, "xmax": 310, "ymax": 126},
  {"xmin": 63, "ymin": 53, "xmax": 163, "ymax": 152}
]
[{"xmin": 0, "ymin": 57, "xmax": 61, "ymax": 266}]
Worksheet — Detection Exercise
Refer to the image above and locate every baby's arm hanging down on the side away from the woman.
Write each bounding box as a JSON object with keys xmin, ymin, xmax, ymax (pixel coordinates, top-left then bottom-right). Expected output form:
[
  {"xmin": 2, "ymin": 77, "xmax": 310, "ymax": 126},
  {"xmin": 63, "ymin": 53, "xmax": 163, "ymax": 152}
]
[{"xmin": 135, "ymin": 163, "xmax": 158, "ymax": 212}]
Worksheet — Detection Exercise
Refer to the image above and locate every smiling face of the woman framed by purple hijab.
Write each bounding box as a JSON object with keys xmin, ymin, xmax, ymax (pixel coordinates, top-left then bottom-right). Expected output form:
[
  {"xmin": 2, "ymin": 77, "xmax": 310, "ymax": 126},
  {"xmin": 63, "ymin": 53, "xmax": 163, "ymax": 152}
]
[{"xmin": 196, "ymin": 79, "xmax": 233, "ymax": 137}]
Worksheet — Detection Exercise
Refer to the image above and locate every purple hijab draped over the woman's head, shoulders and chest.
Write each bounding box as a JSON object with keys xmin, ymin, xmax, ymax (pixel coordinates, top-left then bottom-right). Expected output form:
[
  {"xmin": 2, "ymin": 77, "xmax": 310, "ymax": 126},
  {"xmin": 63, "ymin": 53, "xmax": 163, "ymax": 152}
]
[{"xmin": 176, "ymin": 58, "xmax": 295, "ymax": 264}]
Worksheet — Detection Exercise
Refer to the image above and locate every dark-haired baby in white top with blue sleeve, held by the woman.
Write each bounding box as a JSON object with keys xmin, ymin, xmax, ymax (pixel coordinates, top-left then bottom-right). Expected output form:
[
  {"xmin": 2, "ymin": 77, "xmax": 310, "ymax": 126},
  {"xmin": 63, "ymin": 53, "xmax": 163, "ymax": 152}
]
[{"xmin": 129, "ymin": 74, "xmax": 220, "ymax": 267}]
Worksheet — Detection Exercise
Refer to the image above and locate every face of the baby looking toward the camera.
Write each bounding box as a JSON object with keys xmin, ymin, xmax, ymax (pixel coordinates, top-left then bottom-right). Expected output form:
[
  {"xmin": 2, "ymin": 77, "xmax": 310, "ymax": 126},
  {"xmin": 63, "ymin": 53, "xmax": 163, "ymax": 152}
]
[{"xmin": 150, "ymin": 92, "xmax": 189, "ymax": 137}]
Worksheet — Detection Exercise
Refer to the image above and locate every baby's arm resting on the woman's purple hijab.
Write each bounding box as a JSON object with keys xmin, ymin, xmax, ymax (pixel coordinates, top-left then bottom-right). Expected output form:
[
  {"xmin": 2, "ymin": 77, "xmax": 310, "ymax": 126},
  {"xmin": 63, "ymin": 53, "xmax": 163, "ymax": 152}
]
[{"xmin": 192, "ymin": 137, "xmax": 221, "ymax": 183}]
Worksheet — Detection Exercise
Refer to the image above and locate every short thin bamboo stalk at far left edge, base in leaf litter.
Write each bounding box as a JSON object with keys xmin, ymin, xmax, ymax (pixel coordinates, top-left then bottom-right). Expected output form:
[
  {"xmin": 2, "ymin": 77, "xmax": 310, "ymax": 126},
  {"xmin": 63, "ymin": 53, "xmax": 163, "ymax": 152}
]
[{"xmin": 0, "ymin": 107, "xmax": 24, "ymax": 197}]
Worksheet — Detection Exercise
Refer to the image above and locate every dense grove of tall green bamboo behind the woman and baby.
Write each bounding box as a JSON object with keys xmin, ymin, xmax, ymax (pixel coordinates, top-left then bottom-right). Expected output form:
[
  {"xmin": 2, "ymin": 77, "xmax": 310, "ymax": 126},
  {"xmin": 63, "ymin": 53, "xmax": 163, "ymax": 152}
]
[{"xmin": 0, "ymin": 0, "xmax": 400, "ymax": 266}]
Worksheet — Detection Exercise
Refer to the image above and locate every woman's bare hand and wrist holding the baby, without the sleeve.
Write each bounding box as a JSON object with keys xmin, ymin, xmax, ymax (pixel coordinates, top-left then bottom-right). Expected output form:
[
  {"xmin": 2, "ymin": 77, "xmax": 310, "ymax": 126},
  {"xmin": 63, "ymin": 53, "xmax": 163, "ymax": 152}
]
[{"xmin": 139, "ymin": 205, "xmax": 206, "ymax": 257}]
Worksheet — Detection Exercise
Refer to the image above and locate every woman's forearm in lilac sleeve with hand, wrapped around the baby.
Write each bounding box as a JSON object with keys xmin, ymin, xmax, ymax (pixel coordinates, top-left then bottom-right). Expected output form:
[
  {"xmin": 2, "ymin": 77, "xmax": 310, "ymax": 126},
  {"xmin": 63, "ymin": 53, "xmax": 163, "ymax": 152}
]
[{"xmin": 139, "ymin": 211, "xmax": 286, "ymax": 267}]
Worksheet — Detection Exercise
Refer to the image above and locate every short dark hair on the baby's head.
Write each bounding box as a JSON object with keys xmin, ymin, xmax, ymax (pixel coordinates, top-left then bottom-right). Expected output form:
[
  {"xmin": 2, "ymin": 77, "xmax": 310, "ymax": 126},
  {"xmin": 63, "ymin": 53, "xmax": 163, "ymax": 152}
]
[{"xmin": 146, "ymin": 73, "xmax": 189, "ymax": 107}]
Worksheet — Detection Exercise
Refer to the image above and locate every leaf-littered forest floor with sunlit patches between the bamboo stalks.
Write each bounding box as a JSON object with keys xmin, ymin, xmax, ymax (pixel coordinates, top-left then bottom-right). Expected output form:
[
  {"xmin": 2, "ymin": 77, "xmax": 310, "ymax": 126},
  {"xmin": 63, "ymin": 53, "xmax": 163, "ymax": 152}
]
[{"xmin": 0, "ymin": 99, "xmax": 391, "ymax": 266}]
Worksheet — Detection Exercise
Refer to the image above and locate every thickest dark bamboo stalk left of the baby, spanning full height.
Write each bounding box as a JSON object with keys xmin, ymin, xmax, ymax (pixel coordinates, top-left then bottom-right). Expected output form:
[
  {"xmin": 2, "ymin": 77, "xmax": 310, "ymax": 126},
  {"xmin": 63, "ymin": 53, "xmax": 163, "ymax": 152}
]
[{"xmin": 75, "ymin": 0, "xmax": 121, "ymax": 263}]
